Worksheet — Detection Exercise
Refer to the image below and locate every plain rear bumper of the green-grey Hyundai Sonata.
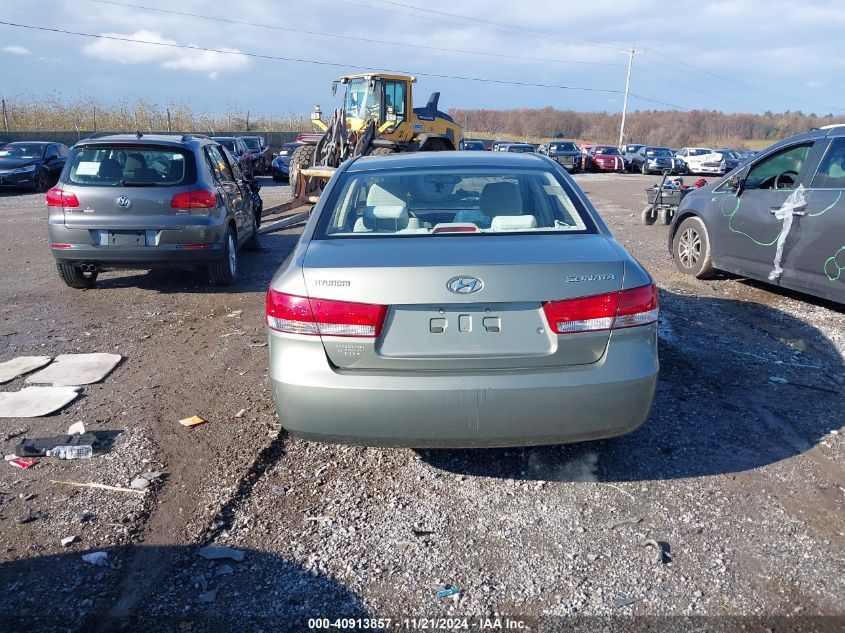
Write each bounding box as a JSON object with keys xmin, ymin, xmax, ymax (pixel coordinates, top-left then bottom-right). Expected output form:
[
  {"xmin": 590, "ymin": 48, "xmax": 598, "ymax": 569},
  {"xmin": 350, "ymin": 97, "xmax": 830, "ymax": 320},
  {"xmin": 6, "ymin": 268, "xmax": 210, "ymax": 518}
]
[{"xmin": 269, "ymin": 325, "xmax": 658, "ymax": 447}]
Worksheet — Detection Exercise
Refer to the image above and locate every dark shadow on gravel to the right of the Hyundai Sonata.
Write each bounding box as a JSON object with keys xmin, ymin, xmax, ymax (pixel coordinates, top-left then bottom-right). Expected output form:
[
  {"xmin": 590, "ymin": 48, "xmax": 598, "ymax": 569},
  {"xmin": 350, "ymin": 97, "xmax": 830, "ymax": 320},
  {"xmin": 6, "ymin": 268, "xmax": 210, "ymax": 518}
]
[{"xmin": 418, "ymin": 291, "xmax": 845, "ymax": 482}]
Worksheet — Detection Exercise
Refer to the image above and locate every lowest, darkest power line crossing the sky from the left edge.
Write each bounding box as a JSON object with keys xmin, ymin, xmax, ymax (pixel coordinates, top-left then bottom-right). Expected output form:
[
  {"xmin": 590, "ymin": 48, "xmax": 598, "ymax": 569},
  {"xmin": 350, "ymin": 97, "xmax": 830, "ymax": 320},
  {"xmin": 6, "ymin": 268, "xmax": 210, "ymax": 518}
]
[{"xmin": 0, "ymin": 21, "xmax": 640, "ymax": 97}]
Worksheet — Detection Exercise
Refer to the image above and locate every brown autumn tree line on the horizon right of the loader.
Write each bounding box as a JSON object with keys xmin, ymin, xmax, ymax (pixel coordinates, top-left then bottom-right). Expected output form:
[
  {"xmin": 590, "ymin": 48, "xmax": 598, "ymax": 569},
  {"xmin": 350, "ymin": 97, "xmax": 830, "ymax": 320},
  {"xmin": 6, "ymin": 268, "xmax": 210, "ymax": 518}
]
[{"xmin": 449, "ymin": 106, "xmax": 845, "ymax": 149}]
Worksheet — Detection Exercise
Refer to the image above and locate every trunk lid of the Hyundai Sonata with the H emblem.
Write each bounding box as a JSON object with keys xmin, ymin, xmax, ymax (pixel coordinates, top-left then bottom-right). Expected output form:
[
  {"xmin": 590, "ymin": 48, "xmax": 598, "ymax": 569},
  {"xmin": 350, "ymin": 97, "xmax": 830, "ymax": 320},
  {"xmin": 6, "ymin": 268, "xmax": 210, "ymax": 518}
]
[{"xmin": 303, "ymin": 234, "xmax": 624, "ymax": 370}]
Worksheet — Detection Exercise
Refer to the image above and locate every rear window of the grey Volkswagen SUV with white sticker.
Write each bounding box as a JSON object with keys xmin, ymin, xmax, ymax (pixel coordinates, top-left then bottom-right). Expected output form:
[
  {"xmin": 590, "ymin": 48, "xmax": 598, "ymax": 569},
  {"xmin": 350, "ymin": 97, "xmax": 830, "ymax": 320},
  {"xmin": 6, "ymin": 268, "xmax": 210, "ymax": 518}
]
[{"xmin": 65, "ymin": 145, "xmax": 196, "ymax": 187}]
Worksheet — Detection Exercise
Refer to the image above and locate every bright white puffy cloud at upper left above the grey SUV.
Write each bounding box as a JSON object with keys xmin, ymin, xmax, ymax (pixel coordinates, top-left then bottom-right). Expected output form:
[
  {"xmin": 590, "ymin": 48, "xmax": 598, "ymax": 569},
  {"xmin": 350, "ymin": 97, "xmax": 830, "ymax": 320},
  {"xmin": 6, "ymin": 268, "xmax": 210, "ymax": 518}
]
[{"xmin": 82, "ymin": 30, "xmax": 249, "ymax": 79}]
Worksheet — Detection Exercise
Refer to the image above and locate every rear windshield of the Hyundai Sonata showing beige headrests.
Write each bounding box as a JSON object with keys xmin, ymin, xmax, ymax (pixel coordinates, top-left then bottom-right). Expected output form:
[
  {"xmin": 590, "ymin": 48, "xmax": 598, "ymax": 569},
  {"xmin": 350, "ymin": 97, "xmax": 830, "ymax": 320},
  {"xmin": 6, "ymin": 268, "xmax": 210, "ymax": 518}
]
[{"xmin": 315, "ymin": 167, "xmax": 596, "ymax": 239}]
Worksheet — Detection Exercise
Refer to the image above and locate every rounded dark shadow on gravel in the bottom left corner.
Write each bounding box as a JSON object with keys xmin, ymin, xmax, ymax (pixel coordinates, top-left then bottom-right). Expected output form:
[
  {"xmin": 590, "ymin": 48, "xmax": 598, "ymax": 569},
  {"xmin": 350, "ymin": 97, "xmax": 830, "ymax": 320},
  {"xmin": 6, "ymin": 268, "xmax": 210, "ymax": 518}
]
[{"xmin": 0, "ymin": 545, "xmax": 367, "ymax": 632}]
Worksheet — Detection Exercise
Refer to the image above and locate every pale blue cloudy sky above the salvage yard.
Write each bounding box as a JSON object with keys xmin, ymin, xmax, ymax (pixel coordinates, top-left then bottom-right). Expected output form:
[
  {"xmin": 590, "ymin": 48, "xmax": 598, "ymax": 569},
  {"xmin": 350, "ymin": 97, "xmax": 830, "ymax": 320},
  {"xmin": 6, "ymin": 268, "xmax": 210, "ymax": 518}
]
[{"xmin": 0, "ymin": 0, "xmax": 845, "ymax": 116}]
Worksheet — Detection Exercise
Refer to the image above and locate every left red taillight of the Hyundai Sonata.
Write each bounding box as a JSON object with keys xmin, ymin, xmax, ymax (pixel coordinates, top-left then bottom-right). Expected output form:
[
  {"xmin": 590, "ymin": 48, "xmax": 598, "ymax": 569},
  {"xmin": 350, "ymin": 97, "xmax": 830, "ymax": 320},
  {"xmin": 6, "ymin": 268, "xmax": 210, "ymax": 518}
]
[{"xmin": 267, "ymin": 288, "xmax": 387, "ymax": 338}]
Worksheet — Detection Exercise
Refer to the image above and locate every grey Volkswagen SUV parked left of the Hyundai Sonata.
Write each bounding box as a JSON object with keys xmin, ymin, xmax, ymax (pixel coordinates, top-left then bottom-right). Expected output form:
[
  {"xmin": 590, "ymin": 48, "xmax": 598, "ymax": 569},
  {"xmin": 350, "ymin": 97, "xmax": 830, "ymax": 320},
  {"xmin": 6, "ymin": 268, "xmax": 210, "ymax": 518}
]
[{"xmin": 47, "ymin": 134, "xmax": 260, "ymax": 288}]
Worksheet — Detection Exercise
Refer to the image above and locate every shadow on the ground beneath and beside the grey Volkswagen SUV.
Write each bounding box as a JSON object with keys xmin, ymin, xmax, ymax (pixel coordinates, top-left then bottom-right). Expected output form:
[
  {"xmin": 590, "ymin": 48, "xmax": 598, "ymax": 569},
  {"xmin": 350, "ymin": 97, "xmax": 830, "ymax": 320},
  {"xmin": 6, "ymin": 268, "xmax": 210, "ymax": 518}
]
[{"xmin": 93, "ymin": 233, "xmax": 299, "ymax": 294}]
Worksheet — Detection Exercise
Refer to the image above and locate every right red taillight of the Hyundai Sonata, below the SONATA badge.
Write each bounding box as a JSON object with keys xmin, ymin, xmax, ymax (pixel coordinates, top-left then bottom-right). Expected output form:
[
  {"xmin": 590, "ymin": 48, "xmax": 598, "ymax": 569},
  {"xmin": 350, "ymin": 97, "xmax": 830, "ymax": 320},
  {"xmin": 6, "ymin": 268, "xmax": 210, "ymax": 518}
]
[{"xmin": 543, "ymin": 284, "xmax": 658, "ymax": 334}]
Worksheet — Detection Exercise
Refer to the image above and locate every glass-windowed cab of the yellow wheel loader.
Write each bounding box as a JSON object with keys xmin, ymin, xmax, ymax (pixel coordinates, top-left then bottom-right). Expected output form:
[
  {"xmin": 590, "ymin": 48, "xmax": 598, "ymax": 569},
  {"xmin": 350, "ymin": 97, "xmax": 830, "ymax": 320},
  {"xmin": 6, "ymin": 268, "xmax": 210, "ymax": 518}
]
[{"xmin": 340, "ymin": 75, "xmax": 414, "ymax": 125}]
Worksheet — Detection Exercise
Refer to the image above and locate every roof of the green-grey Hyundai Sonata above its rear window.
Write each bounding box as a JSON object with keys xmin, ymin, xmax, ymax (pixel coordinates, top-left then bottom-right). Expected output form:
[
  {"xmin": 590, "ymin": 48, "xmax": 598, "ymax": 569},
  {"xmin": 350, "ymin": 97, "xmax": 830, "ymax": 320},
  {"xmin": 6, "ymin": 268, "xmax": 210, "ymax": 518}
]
[{"xmin": 347, "ymin": 151, "xmax": 547, "ymax": 172}]
